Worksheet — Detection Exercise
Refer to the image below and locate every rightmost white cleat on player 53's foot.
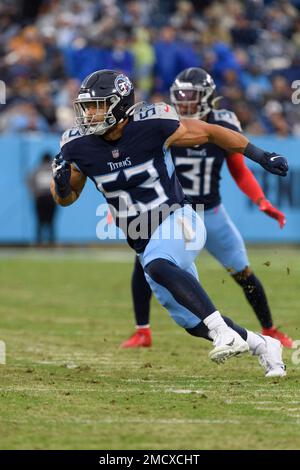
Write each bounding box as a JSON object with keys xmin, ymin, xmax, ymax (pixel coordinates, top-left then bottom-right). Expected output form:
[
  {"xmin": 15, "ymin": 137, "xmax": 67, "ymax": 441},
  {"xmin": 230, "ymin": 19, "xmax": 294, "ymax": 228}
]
[{"xmin": 258, "ymin": 335, "xmax": 286, "ymax": 377}]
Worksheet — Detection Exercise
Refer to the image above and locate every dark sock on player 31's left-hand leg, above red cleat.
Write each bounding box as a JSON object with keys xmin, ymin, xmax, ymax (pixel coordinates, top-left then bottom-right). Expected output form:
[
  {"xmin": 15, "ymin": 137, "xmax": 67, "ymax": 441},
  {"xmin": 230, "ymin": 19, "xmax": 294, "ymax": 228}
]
[{"xmin": 131, "ymin": 257, "xmax": 152, "ymax": 327}]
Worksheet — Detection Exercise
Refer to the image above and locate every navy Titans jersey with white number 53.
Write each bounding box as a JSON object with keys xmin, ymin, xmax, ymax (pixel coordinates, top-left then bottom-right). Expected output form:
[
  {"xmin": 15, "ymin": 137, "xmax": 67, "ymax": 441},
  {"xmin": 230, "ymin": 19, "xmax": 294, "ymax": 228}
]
[{"xmin": 61, "ymin": 103, "xmax": 184, "ymax": 253}]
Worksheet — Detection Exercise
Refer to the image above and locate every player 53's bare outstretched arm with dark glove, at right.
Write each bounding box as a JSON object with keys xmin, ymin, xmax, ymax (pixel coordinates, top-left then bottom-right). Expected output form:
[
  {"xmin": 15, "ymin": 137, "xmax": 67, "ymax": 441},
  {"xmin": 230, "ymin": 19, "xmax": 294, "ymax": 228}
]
[{"xmin": 166, "ymin": 119, "xmax": 288, "ymax": 176}]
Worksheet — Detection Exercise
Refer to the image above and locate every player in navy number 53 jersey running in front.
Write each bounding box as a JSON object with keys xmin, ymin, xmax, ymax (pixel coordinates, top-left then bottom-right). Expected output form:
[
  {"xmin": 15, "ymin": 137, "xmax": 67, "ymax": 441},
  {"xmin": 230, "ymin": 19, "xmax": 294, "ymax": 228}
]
[{"xmin": 51, "ymin": 70, "xmax": 288, "ymax": 377}]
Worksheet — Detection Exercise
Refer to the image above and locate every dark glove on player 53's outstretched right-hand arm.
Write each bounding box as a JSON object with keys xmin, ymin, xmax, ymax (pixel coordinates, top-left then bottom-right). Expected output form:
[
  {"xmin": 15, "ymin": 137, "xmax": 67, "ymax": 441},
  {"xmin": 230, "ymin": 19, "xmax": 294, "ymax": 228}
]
[{"xmin": 244, "ymin": 142, "xmax": 289, "ymax": 176}]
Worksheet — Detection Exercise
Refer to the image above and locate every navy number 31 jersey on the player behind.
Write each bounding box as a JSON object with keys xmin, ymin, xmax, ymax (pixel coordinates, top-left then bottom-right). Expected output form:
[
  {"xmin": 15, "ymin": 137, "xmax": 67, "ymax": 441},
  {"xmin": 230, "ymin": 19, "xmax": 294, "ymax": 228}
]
[{"xmin": 172, "ymin": 109, "xmax": 241, "ymax": 210}]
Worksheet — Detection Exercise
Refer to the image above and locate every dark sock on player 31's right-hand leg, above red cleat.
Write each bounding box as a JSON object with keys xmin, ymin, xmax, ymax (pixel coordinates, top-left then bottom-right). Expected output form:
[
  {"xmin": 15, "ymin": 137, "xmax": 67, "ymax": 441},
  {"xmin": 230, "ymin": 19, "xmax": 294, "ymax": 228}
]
[{"xmin": 233, "ymin": 273, "xmax": 273, "ymax": 328}]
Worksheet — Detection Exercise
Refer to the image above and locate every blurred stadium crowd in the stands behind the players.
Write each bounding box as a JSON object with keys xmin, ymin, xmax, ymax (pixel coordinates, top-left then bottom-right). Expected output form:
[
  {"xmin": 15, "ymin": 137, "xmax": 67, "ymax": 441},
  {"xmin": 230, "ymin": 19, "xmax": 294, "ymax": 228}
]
[{"xmin": 0, "ymin": 0, "xmax": 300, "ymax": 136}]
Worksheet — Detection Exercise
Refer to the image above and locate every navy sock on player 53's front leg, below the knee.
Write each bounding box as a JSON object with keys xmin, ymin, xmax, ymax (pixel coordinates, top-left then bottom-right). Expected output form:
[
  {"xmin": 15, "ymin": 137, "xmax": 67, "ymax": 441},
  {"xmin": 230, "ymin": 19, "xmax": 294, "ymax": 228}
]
[{"xmin": 145, "ymin": 258, "xmax": 217, "ymax": 320}]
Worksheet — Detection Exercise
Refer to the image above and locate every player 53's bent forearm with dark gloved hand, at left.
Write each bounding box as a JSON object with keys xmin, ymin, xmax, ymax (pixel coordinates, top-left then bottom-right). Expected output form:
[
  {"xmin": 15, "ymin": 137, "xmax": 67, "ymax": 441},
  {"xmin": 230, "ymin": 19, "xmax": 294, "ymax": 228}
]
[{"xmin": 50, "ymin": 154, "xmax": 86, "ymax": 206}]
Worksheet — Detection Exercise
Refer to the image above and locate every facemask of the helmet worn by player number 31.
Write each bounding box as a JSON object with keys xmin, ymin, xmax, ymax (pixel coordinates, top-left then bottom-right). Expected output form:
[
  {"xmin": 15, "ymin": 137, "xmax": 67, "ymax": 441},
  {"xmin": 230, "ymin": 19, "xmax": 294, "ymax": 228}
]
[{"xmin": 170, "ymin": 80, "xmax": 216, "ymax": 119}]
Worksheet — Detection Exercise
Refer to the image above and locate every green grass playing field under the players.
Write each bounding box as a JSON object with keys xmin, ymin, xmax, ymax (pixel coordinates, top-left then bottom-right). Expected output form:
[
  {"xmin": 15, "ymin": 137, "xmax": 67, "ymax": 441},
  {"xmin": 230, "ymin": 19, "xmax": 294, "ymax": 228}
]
[{"xmin": 0, "ymin": 247, "xmax": 300, "ymax": 450}]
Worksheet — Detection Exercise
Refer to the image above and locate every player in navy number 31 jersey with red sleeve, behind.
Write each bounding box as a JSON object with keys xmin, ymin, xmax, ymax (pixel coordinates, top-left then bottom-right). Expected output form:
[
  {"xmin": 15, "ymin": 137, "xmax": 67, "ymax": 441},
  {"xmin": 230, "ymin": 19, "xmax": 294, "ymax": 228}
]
[{"xmin": 122, "ymin": 68, "xmax": 293, "ymax": 348}]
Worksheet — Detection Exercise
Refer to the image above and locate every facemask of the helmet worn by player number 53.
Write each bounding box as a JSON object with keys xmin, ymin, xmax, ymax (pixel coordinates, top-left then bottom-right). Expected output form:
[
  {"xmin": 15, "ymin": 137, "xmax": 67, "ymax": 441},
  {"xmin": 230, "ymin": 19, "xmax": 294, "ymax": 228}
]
[{"xmin": 74, "ymin": 95, "xmax": 121, "ymax": 135}]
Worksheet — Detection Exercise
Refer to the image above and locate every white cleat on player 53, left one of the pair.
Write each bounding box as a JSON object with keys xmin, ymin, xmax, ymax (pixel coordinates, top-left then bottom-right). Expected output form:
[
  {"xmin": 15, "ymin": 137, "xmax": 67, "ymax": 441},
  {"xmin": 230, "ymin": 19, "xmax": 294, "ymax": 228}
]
[{"xmin": 209, "ymin": 326, "xmax": 249, "ymax": 364}]
